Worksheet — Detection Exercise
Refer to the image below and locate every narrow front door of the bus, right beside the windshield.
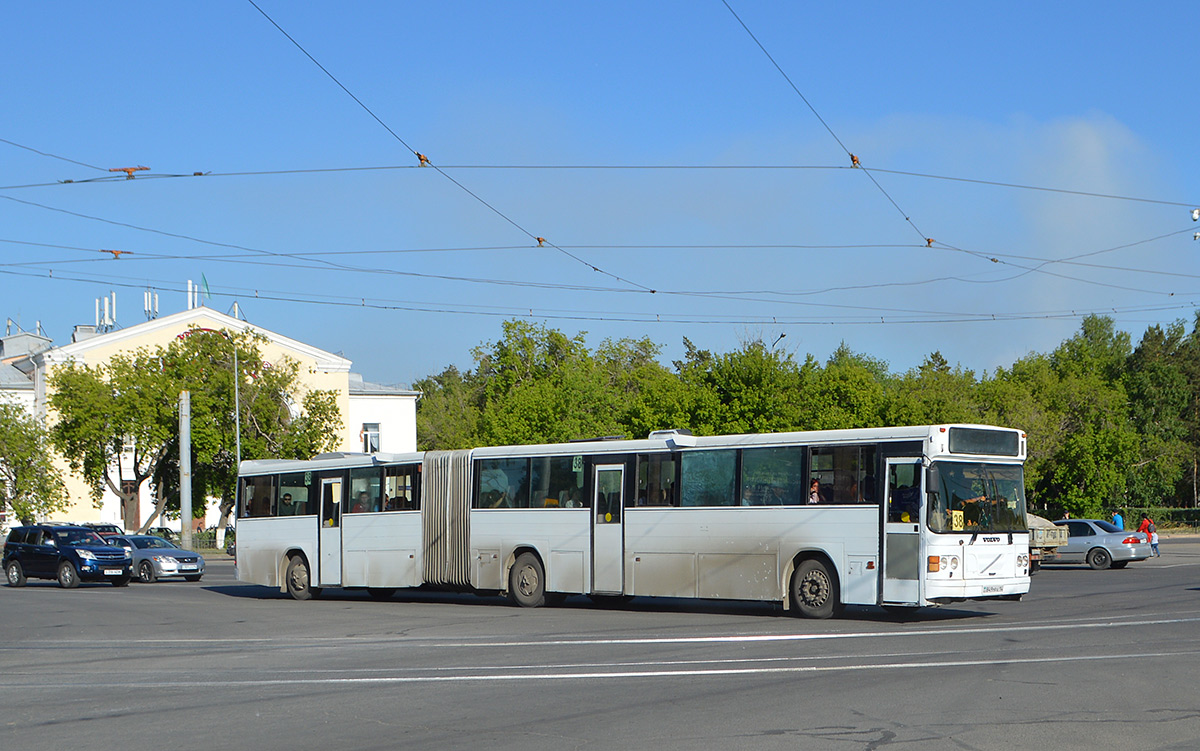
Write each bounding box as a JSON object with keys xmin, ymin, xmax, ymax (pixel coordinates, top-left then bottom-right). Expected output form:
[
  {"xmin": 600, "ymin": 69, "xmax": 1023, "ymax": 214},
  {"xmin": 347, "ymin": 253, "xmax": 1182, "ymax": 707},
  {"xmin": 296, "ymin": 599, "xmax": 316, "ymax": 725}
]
[{"xmin": 880, "ymin": 458, "xmax": 925, "ymax": 605}]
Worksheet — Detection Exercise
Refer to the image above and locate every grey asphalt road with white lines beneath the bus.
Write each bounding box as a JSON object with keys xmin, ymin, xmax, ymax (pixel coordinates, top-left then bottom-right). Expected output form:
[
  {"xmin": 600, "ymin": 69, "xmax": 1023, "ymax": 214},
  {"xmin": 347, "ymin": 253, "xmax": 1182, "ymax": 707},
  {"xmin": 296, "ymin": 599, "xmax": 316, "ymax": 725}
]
[{"xmin": 0, "ymin": 539, "xmax": 1200, "ymax": 751}]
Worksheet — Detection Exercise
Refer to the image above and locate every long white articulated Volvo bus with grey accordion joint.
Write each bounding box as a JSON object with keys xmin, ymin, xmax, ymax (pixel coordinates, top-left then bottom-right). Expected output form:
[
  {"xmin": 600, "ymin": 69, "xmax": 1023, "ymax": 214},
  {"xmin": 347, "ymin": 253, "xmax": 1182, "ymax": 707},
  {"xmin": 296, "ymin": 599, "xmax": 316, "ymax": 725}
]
[{"xmin": 236, "ymin": 425, "xmax": 1030, "ymax": 618}]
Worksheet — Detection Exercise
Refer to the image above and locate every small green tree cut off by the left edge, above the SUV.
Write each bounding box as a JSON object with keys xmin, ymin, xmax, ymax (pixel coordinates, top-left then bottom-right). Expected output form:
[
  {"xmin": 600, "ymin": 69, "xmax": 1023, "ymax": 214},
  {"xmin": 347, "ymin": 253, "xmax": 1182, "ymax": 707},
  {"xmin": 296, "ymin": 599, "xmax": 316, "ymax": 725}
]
[{"xmin": 0, "ymin": 402, "xmax": 70, "ymax": 523}]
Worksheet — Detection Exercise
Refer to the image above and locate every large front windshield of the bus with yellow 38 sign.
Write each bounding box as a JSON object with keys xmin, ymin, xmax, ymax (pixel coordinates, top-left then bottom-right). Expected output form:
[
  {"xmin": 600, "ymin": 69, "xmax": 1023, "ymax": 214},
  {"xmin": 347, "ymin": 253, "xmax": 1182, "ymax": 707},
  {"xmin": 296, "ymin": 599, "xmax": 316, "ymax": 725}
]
[{"xmin": 929, "ymin": 462, "xmax": 1028, "ymax": 533}]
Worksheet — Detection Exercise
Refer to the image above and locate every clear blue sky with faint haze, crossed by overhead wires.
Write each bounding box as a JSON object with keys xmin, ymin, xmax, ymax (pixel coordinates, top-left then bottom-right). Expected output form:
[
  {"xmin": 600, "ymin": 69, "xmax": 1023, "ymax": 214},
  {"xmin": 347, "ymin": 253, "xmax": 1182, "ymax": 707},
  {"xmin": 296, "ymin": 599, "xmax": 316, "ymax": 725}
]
[{"xmin": 0, "ymin": 0, "xmax": 1200, "ymax": 385}]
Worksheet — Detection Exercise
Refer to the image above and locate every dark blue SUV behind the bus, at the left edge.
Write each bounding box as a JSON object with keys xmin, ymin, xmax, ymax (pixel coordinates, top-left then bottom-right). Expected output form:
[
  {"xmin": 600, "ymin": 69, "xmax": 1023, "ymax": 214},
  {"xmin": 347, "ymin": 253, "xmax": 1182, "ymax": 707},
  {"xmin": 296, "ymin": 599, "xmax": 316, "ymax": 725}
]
[{"xmin": 4, "ymin": 524, "xmax": 133, "ymax": 589}]
